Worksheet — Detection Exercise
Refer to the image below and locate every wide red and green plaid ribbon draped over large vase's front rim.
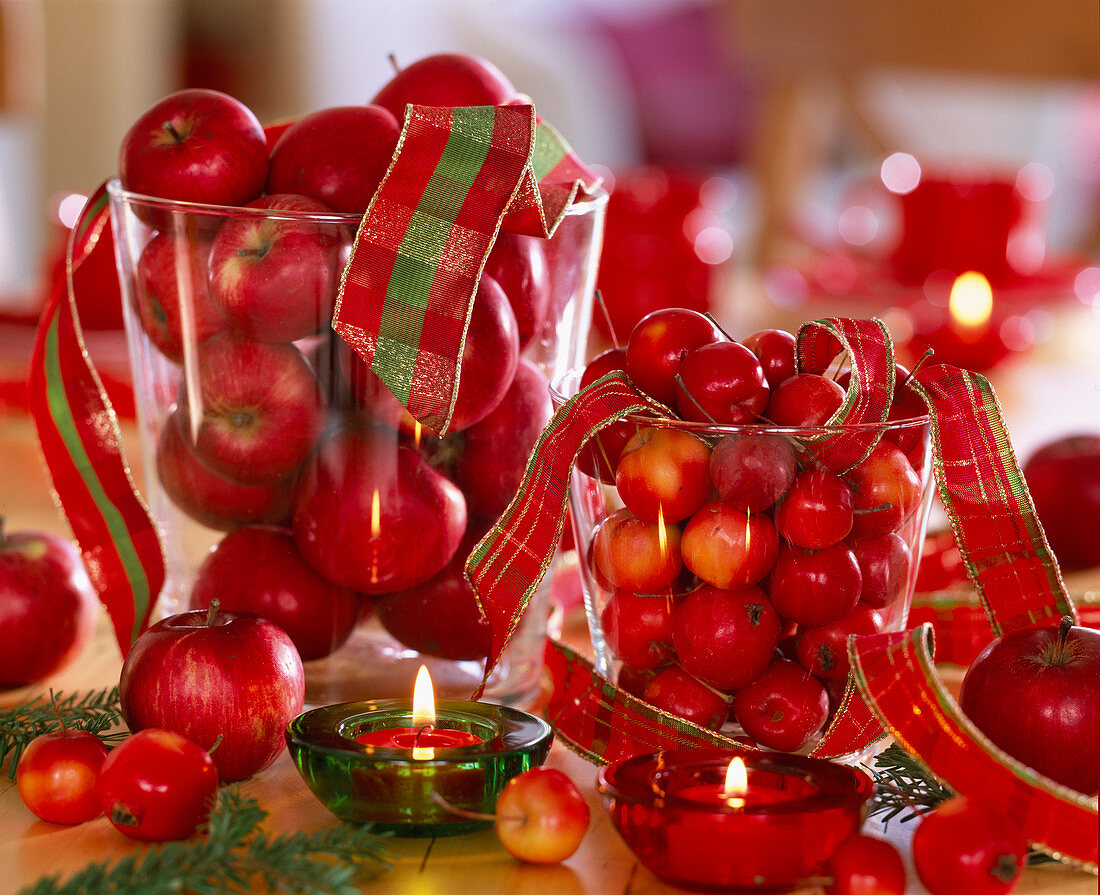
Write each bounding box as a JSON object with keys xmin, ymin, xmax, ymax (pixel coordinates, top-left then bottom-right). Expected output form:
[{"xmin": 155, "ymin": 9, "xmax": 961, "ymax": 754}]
[{"xmin": 332, "ymin": 104, "xmax": 598, "ymax": 433}]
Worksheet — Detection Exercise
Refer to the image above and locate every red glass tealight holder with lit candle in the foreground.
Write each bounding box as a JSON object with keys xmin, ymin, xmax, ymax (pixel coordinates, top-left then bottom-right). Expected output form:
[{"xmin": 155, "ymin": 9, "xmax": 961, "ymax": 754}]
[{"xmin": 600, "ymin": 749, "xmax": 872, "ymax": 892}]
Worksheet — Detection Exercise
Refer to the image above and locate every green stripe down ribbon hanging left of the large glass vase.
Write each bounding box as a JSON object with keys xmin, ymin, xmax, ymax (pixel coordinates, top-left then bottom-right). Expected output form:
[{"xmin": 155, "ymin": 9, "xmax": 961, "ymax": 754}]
[{"xmin": 45, "ymin": 314, "xmax": 150, "ymax": 642}]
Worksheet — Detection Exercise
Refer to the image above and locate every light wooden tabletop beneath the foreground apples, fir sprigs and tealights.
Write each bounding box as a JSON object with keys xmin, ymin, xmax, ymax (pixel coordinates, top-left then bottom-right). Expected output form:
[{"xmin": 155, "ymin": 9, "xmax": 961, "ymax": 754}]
[{"xmin": 0, "ymin": 413, "xmax": 1097, "ymax": 895}]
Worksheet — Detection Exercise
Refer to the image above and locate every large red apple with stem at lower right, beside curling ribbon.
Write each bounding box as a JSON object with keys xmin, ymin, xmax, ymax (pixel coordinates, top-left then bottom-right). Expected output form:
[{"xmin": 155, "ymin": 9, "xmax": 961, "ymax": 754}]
[{"xmin": 959, "ymin": 616, "xmax": 1100, "ymax": 795}]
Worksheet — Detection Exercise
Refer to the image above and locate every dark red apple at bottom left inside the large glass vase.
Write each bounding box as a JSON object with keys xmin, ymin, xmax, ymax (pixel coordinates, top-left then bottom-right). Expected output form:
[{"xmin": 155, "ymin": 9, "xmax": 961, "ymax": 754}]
[{"xmin": 191, "ymin": 526, "xmax": 360, "ymax": 662}]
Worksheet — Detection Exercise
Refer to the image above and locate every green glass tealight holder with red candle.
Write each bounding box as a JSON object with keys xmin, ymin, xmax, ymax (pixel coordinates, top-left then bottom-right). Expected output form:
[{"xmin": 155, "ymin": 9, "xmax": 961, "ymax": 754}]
[{"xmin": 286, "ymin": 699, "xmax": 553, "ymax": 837}]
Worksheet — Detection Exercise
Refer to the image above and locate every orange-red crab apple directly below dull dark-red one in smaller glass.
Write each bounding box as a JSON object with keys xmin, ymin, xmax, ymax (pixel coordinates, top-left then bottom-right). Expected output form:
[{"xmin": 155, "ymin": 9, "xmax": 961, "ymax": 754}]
[{"xmin": 680, "ymin": 500, "xmax": 779, "ymax": 588}]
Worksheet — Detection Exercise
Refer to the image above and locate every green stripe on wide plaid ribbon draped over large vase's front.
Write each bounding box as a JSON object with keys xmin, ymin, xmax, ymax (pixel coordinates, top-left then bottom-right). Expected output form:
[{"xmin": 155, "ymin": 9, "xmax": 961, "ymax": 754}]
[{"xmin": 372, "ymin": 106, "xmax": 495, "ymax": 404}]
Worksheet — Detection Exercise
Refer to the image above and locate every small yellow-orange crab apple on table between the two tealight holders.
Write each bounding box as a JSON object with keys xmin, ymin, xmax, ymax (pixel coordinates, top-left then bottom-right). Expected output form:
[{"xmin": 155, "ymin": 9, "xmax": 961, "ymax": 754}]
[{"xmin": 494, "ymin": 767, "xmax": 590, "ymax": 864}]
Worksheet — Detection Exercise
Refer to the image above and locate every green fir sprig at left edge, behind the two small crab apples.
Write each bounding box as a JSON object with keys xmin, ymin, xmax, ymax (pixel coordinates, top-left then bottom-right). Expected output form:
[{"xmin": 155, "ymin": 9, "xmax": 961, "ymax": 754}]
[{"xmin": 0, "ymin": 687, "xmax": 128, "ymax": 780}]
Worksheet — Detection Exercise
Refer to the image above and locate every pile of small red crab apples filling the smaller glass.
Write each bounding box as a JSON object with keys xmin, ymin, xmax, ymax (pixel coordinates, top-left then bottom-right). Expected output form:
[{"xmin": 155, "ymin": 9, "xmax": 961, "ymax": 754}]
[{"xmin": 576, "ymin": 308, "xmax": 926, "ymax": 751}]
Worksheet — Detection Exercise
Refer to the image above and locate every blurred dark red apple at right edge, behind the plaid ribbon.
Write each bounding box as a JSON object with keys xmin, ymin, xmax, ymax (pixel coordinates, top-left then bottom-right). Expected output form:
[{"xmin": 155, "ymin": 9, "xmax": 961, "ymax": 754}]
[{"xmin": 1023, "ymin": 434, "xmax": 1100, "ymax": 570}]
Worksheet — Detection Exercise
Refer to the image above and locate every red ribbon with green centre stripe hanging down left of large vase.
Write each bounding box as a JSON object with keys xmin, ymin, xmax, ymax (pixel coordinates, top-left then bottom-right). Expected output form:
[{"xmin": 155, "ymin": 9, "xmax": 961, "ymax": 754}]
[{"xmin": 28, "ymin": 187, "xmax": 164, "ymax": 655}]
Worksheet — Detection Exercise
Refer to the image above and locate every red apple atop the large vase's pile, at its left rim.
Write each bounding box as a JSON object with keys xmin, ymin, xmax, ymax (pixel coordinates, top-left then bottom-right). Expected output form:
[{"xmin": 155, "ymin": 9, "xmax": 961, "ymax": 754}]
[{"xmin": 119, "ymin": 89, "xmax": 267, "ymax": 212}]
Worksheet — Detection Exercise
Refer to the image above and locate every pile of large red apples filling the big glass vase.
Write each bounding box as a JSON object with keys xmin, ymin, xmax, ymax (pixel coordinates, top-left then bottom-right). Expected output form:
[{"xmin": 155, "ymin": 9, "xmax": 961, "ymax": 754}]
[{"xmin": 120, "ymin": 55, "xmax": 560, "ymax": 660}]
